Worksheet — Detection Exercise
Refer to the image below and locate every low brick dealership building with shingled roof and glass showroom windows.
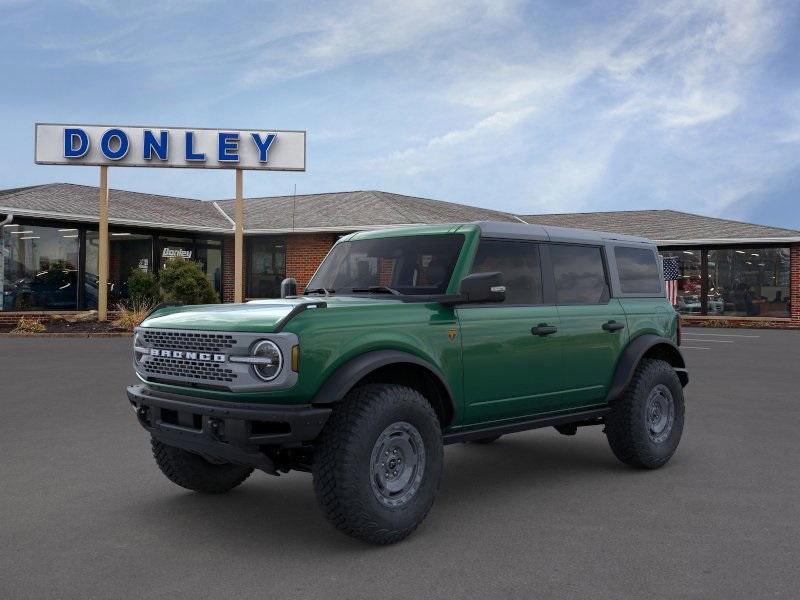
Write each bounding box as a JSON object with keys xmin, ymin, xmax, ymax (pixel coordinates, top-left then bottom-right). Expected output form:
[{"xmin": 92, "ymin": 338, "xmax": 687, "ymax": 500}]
[{"xmin": 0, "ymin": 183, "xmax": 800, "ymax": 328}]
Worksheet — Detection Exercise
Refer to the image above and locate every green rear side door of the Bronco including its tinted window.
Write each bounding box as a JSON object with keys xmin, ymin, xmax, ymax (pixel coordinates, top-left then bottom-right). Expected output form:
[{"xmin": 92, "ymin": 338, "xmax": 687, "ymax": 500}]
[{"xmin": 544, "ymin": 243, "xmax": 628, "ymax": 409}]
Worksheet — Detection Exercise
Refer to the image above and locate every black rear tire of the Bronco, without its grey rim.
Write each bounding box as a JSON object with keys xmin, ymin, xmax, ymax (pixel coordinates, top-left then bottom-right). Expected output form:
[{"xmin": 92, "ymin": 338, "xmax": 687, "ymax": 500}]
[{"xmin": 605, "ymin": 358, "xmax": 685, "ymax": 469}]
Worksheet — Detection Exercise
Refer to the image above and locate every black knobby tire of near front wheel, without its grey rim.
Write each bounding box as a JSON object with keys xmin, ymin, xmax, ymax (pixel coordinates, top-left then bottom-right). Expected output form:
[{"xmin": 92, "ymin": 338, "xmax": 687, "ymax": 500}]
[{"xmin": 312, "ymin": 384, "xmax": 444, "ymax": 544}]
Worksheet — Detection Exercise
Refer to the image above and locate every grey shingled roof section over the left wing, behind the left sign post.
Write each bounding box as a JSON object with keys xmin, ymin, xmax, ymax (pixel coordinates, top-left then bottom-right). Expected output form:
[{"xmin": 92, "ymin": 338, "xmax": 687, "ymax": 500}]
[{"xmin": 0, "ymin": 183, "xmax": 232, "ymax": 231}]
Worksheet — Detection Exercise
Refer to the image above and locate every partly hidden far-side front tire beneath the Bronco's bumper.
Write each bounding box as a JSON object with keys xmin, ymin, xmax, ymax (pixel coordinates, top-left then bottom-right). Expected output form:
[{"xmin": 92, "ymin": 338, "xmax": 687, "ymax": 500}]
[{"xmin": 150, "ymin": 438, "xmax": 253, "ymax": 494}]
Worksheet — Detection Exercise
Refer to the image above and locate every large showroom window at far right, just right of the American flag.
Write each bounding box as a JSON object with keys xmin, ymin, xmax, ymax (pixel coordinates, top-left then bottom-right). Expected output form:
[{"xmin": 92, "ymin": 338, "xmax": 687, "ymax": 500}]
[{"xmin": 708, "ymin": 248, "xmax": 790, "ymax": 318}]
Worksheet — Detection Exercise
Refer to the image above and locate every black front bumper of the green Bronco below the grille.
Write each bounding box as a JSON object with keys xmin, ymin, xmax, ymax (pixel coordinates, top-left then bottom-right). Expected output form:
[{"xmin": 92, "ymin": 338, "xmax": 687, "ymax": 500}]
[{"xmin": 128, "ymin": 385, "xmax": 331, "ymax": 473}]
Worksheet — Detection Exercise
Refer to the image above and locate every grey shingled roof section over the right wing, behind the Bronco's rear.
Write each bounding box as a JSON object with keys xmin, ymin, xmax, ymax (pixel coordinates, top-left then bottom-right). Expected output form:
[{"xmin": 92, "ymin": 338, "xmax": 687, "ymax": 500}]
[{"xmin": 520, "ymin": 210, "xmax": 800, "ymax": 245}]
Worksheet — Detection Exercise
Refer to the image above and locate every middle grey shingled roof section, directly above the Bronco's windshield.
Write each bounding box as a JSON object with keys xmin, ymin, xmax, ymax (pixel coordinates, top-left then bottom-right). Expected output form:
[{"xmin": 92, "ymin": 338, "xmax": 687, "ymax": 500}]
[{"xmin": 212, "ymin": 191, "xmax": 519, "ymax": 232}]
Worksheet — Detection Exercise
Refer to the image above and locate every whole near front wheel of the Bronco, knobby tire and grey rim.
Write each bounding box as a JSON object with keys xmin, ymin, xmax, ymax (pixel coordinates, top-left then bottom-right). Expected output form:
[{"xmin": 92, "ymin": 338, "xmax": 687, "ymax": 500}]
[{"xmin": 313, "ymin": 384, "xmax": 444, "ymax": 544}]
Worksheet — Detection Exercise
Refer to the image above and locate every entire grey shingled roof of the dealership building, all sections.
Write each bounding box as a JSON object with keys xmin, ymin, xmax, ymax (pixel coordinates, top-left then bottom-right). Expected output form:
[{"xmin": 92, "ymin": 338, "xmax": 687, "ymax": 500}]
[{"xmin": 0, "ymin": 183, "xmax": 800, "ymax": 246}]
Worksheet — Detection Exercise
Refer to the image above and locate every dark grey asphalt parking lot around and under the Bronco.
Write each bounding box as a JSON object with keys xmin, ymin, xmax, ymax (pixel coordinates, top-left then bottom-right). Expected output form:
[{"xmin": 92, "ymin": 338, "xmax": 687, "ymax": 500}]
[{"xmin": 0, "ymin": 328, "xmax": 800, "ymax": 600}]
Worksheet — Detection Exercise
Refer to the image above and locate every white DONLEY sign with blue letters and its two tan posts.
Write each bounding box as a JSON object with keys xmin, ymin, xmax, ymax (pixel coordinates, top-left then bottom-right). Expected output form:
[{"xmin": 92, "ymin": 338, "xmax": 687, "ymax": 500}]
[{"xmin": 35, "ymin": 123, "xmax": 306, "ymax": 321}]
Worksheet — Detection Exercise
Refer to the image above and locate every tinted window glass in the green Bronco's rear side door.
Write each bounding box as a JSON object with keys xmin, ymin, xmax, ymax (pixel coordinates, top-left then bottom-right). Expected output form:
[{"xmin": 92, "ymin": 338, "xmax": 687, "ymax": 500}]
[{"xmin": 550, "ymin": 244, "xmax": 609, "ymax": 304}]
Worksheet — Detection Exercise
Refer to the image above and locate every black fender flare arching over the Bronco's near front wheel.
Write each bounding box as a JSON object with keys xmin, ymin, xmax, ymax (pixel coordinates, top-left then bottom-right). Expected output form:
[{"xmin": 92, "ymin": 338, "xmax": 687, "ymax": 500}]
[{"xmin": 311, "ymin": 350, "xmax": 456, "ymax": 414}]
